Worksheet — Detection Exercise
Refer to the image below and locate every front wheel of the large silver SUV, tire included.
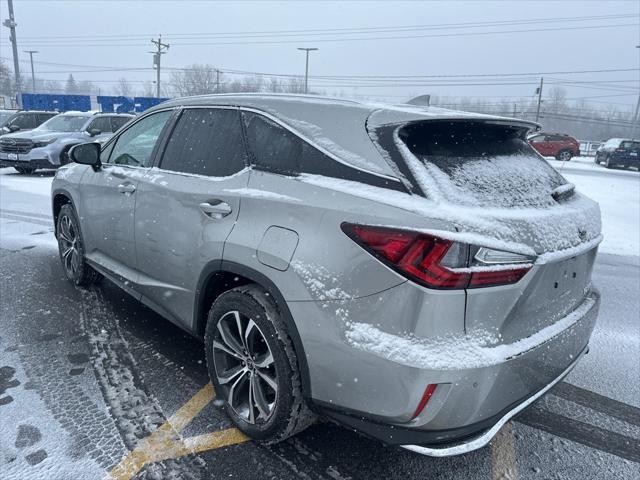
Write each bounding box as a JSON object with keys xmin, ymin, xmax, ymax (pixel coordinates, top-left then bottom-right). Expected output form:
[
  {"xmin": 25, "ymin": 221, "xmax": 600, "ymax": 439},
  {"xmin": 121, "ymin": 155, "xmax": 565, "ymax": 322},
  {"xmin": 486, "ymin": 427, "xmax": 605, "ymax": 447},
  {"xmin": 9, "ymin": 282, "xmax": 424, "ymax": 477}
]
[{"xmin": 56, "ymin": 203, "xmax": 102, "ymax": 287}]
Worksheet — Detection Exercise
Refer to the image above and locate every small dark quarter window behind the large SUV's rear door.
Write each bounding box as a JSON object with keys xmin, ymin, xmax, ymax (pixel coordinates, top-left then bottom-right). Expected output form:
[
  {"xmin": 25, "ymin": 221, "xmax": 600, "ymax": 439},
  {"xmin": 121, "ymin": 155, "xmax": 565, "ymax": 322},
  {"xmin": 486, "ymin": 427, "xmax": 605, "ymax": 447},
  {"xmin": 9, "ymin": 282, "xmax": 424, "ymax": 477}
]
[{"xmin": 242, "ymin": 112, "xmax": 306, "ymax": 174}]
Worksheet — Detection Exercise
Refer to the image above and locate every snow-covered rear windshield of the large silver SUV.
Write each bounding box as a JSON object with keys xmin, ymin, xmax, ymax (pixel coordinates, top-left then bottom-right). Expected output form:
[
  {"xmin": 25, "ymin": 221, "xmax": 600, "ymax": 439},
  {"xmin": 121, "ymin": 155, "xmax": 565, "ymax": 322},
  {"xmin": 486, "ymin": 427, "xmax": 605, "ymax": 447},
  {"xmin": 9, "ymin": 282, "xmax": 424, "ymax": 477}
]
[{"xmin": 376, "ymin": 121, "xmax": 567, "ymax": 207}]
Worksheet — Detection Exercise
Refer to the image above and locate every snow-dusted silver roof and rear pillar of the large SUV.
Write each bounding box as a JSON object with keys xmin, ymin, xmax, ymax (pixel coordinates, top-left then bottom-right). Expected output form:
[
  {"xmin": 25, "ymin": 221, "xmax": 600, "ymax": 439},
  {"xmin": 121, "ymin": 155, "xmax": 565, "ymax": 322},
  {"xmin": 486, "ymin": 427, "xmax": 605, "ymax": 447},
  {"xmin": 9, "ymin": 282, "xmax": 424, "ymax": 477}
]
[{"xmin": 154, "ymin": 93, "xmax": 537, "ymax": 178}]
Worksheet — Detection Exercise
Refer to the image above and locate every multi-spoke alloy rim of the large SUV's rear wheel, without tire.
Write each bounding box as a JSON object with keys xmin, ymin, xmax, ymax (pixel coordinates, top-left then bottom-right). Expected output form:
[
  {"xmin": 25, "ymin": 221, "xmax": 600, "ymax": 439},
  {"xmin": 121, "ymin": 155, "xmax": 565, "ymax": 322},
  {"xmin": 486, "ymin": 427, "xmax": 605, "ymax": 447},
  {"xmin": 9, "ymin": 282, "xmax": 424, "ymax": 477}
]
[{"xmin": 213, "ymin": 310, "xmax": 278, "ymax": 424}]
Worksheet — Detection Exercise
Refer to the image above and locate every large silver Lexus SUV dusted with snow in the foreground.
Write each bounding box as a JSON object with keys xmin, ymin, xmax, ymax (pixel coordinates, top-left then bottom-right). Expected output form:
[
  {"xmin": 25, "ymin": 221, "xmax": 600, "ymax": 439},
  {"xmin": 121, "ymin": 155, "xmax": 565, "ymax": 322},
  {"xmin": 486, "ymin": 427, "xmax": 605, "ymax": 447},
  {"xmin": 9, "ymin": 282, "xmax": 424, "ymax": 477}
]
[{"xmin": 52, "ymin": 95, "xmax": 602, "ymax": 456}]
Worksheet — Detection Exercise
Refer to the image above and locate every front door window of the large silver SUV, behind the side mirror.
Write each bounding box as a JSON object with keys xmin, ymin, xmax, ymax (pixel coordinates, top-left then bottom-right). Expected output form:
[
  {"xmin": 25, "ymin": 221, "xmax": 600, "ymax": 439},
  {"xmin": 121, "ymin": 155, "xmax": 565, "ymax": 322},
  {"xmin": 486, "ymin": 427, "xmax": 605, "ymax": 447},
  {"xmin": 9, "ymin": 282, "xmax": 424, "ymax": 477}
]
[{"xmin": 105, "ymin": 110, "xmax": 173, "ymax": 167}]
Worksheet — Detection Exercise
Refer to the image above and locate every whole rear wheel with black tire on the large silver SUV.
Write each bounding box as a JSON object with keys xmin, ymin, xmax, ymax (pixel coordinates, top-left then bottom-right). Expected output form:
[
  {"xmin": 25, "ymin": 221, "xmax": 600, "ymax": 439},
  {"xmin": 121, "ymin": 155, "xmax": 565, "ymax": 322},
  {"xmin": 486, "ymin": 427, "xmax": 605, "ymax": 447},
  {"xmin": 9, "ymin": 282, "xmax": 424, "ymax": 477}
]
[{"xmin": 205, "ymin": 285, "xmax": 316, "ymax": 444}]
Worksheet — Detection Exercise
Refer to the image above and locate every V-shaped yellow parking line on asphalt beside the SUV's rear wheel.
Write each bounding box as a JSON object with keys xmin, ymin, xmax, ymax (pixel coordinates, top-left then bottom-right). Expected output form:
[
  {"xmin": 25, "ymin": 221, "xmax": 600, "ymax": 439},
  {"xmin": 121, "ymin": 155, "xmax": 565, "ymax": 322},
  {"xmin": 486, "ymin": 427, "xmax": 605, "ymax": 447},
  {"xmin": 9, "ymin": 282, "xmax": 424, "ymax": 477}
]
[{"xmin": 107, "ymin": 383, "xmax": 249, "ymax": 480}]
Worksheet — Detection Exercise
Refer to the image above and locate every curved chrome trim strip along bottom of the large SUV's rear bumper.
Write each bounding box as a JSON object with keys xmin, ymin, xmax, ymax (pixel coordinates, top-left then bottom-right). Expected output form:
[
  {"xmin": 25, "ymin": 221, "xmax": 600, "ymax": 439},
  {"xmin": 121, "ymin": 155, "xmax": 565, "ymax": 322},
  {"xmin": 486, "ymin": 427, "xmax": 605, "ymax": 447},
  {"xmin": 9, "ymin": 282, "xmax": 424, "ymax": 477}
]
[{"xmin": 400, "ymin": 347, "xmax": 589, "ymax": 457}]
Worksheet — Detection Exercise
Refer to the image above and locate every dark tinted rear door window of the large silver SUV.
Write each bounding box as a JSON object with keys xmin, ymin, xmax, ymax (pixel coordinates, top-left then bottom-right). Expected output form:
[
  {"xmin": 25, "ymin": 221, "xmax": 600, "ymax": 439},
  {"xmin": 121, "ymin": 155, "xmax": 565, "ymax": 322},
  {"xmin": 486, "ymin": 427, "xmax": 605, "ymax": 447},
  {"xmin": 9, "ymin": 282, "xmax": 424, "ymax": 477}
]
[{"xmin": 160, "ymin": 108, "xmax": 246, "ymax": 177}]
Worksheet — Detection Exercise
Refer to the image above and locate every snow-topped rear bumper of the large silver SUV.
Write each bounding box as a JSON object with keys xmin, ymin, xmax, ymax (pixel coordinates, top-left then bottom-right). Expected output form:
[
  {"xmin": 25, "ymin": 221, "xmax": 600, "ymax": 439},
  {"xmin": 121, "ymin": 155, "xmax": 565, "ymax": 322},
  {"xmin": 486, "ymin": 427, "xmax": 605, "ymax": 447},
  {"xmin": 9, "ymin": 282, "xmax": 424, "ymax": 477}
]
[{"xmin": 312, "ymin": 290, "xmax": 600, "ymax": 456}]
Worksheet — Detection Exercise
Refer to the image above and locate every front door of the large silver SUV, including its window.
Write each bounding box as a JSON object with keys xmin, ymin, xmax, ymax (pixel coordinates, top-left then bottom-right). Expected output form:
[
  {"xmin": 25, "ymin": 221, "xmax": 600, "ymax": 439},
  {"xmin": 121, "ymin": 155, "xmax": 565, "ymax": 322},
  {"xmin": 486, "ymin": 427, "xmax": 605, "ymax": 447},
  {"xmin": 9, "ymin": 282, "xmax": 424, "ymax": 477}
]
[{"xmin": 78, "ymin": 110, "xmax": 173, "ymax": 287}]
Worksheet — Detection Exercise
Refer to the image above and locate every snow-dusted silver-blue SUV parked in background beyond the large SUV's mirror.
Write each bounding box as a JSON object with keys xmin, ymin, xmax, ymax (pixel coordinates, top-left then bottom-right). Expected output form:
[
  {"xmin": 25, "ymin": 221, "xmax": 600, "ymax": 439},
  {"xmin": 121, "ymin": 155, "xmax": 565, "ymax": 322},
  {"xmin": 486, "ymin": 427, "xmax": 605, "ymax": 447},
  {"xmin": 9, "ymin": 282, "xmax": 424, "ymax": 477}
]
[{"xmin": 0, "ymin": 112, "xmax": 133, "ymax": 174}]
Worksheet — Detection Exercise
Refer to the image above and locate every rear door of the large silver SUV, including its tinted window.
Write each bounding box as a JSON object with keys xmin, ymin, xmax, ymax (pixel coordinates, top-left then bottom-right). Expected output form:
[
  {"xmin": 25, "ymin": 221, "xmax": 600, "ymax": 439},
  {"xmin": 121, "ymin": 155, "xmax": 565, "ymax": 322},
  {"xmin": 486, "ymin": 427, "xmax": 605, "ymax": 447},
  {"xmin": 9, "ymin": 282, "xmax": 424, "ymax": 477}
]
[{"xmin": 135, "ymin": 108, "xmax": 249, "ymax": 328}]
